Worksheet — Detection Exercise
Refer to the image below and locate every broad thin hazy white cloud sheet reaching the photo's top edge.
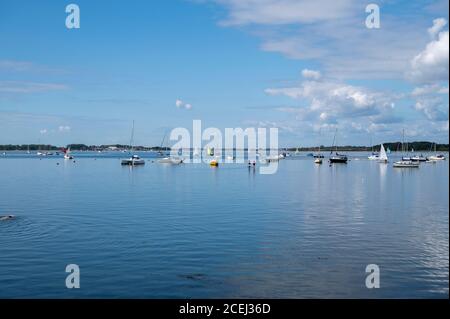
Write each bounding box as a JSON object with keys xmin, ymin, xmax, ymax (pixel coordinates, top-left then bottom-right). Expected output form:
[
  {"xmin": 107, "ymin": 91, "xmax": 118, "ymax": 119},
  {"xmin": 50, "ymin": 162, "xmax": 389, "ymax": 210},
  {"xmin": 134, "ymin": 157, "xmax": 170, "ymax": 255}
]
[{"xmin": 207, "ymin": 0, "xmax": 429, "ymax": 79}]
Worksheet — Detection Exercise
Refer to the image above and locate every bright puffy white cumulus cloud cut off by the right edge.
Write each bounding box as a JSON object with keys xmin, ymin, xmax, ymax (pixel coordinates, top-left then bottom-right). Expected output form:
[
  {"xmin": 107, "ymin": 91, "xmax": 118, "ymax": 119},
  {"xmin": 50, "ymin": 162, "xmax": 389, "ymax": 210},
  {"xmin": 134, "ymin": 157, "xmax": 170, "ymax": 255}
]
[{"xmin": 409, "ymin": 19, "xmax": 449, "ymax": 83}]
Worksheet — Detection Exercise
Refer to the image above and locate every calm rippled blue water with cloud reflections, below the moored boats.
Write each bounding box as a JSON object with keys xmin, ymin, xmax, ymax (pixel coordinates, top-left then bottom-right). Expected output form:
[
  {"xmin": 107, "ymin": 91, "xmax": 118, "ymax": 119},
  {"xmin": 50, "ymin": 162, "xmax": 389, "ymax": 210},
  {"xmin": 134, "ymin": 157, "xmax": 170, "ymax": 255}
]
[{"xmin": 0, "ymin": 153, "xmax": 449, "ymax": 298}]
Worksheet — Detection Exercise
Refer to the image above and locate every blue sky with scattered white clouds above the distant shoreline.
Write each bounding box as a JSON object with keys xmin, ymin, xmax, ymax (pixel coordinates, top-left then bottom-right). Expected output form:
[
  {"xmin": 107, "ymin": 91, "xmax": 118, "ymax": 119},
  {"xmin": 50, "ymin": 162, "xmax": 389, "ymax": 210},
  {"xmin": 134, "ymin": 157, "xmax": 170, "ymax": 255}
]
[{"xmin": 0, "ymin": 0, "xmax": 449, "ymax": 147}]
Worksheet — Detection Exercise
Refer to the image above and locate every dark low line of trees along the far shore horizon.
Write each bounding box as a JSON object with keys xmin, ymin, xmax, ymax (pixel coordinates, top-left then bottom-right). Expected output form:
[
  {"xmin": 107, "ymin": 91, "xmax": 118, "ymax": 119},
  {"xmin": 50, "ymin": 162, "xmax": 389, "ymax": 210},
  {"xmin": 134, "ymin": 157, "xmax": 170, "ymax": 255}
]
[{"xmin": 0, "ymin": 142, "xmax": 449, "ymax": 152}]
